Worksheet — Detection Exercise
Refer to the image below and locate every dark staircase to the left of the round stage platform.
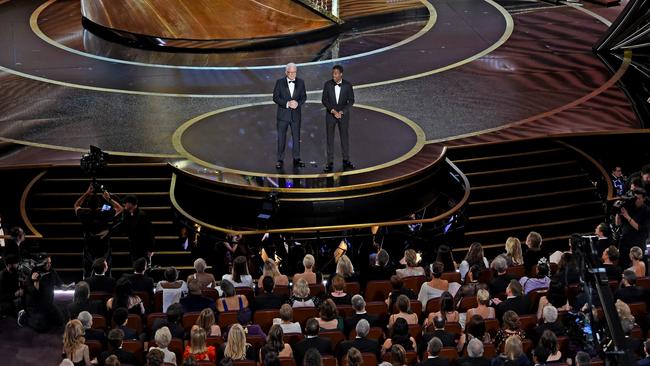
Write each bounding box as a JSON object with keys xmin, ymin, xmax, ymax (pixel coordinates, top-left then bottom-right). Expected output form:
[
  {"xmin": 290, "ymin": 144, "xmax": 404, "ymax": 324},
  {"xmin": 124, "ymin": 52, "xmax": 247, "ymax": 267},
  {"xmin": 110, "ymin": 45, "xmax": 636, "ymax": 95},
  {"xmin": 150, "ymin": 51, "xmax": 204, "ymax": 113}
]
[{"xmin": 23, "ymin": 162, "xmax": 192, "ymax": 281}]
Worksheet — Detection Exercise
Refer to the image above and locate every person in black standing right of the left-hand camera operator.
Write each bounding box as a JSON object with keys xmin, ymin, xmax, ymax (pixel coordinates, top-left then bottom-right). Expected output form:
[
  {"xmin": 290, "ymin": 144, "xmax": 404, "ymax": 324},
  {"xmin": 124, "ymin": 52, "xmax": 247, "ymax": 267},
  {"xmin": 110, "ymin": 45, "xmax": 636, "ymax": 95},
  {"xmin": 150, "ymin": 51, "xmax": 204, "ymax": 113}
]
[{"xmin": 120, "ymin": 195, "xmax": 155, "ymax": 262}]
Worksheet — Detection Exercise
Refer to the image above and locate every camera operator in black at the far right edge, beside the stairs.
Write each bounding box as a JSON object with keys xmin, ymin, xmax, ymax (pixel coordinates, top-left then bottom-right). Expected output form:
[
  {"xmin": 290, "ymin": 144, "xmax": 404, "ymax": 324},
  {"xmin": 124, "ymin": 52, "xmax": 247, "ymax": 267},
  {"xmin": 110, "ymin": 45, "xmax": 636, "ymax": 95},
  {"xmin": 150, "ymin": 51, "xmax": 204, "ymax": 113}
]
[{"xmin": 615, "ymin": 188, "xmax": 650, "ymax": 268}]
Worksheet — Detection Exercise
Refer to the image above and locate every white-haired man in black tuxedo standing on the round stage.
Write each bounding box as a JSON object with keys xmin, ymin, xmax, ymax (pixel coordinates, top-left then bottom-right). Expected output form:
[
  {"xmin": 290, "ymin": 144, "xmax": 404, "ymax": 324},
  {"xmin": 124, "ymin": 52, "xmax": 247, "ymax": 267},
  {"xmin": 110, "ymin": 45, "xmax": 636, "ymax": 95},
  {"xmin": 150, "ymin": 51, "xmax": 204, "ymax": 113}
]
[{"xmin": 273, "ymin": 63, "xmax": 307, "ymax": 169}]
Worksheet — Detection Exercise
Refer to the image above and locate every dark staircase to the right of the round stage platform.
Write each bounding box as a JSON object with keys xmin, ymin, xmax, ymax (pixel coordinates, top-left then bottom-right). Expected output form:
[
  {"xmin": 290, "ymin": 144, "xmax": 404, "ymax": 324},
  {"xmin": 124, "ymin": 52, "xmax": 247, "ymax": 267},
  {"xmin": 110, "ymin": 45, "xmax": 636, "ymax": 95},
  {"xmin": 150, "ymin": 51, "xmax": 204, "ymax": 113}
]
[{"xmin": 449, "ymin": 139, "xmax": 607, "ymax": 258}]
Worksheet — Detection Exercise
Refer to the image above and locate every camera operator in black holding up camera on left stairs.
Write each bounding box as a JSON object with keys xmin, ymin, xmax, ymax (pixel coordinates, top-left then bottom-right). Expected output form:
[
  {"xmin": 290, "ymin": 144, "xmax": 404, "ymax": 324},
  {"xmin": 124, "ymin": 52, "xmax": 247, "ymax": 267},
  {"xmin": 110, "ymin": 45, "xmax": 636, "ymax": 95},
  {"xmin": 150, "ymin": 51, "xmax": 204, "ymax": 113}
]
[{"xmin": 74, "ymin": 184, "xmax": 122, "ymax": 278}]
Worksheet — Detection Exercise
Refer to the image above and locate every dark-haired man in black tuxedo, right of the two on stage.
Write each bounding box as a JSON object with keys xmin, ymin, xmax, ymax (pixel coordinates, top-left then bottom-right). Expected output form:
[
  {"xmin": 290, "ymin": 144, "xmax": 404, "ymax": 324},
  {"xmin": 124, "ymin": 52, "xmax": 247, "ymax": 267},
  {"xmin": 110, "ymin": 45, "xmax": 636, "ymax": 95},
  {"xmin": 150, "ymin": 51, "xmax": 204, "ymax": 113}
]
[{"xmin": 322, "ymin": 65, "xmax": 354, "ymax": 172}]
